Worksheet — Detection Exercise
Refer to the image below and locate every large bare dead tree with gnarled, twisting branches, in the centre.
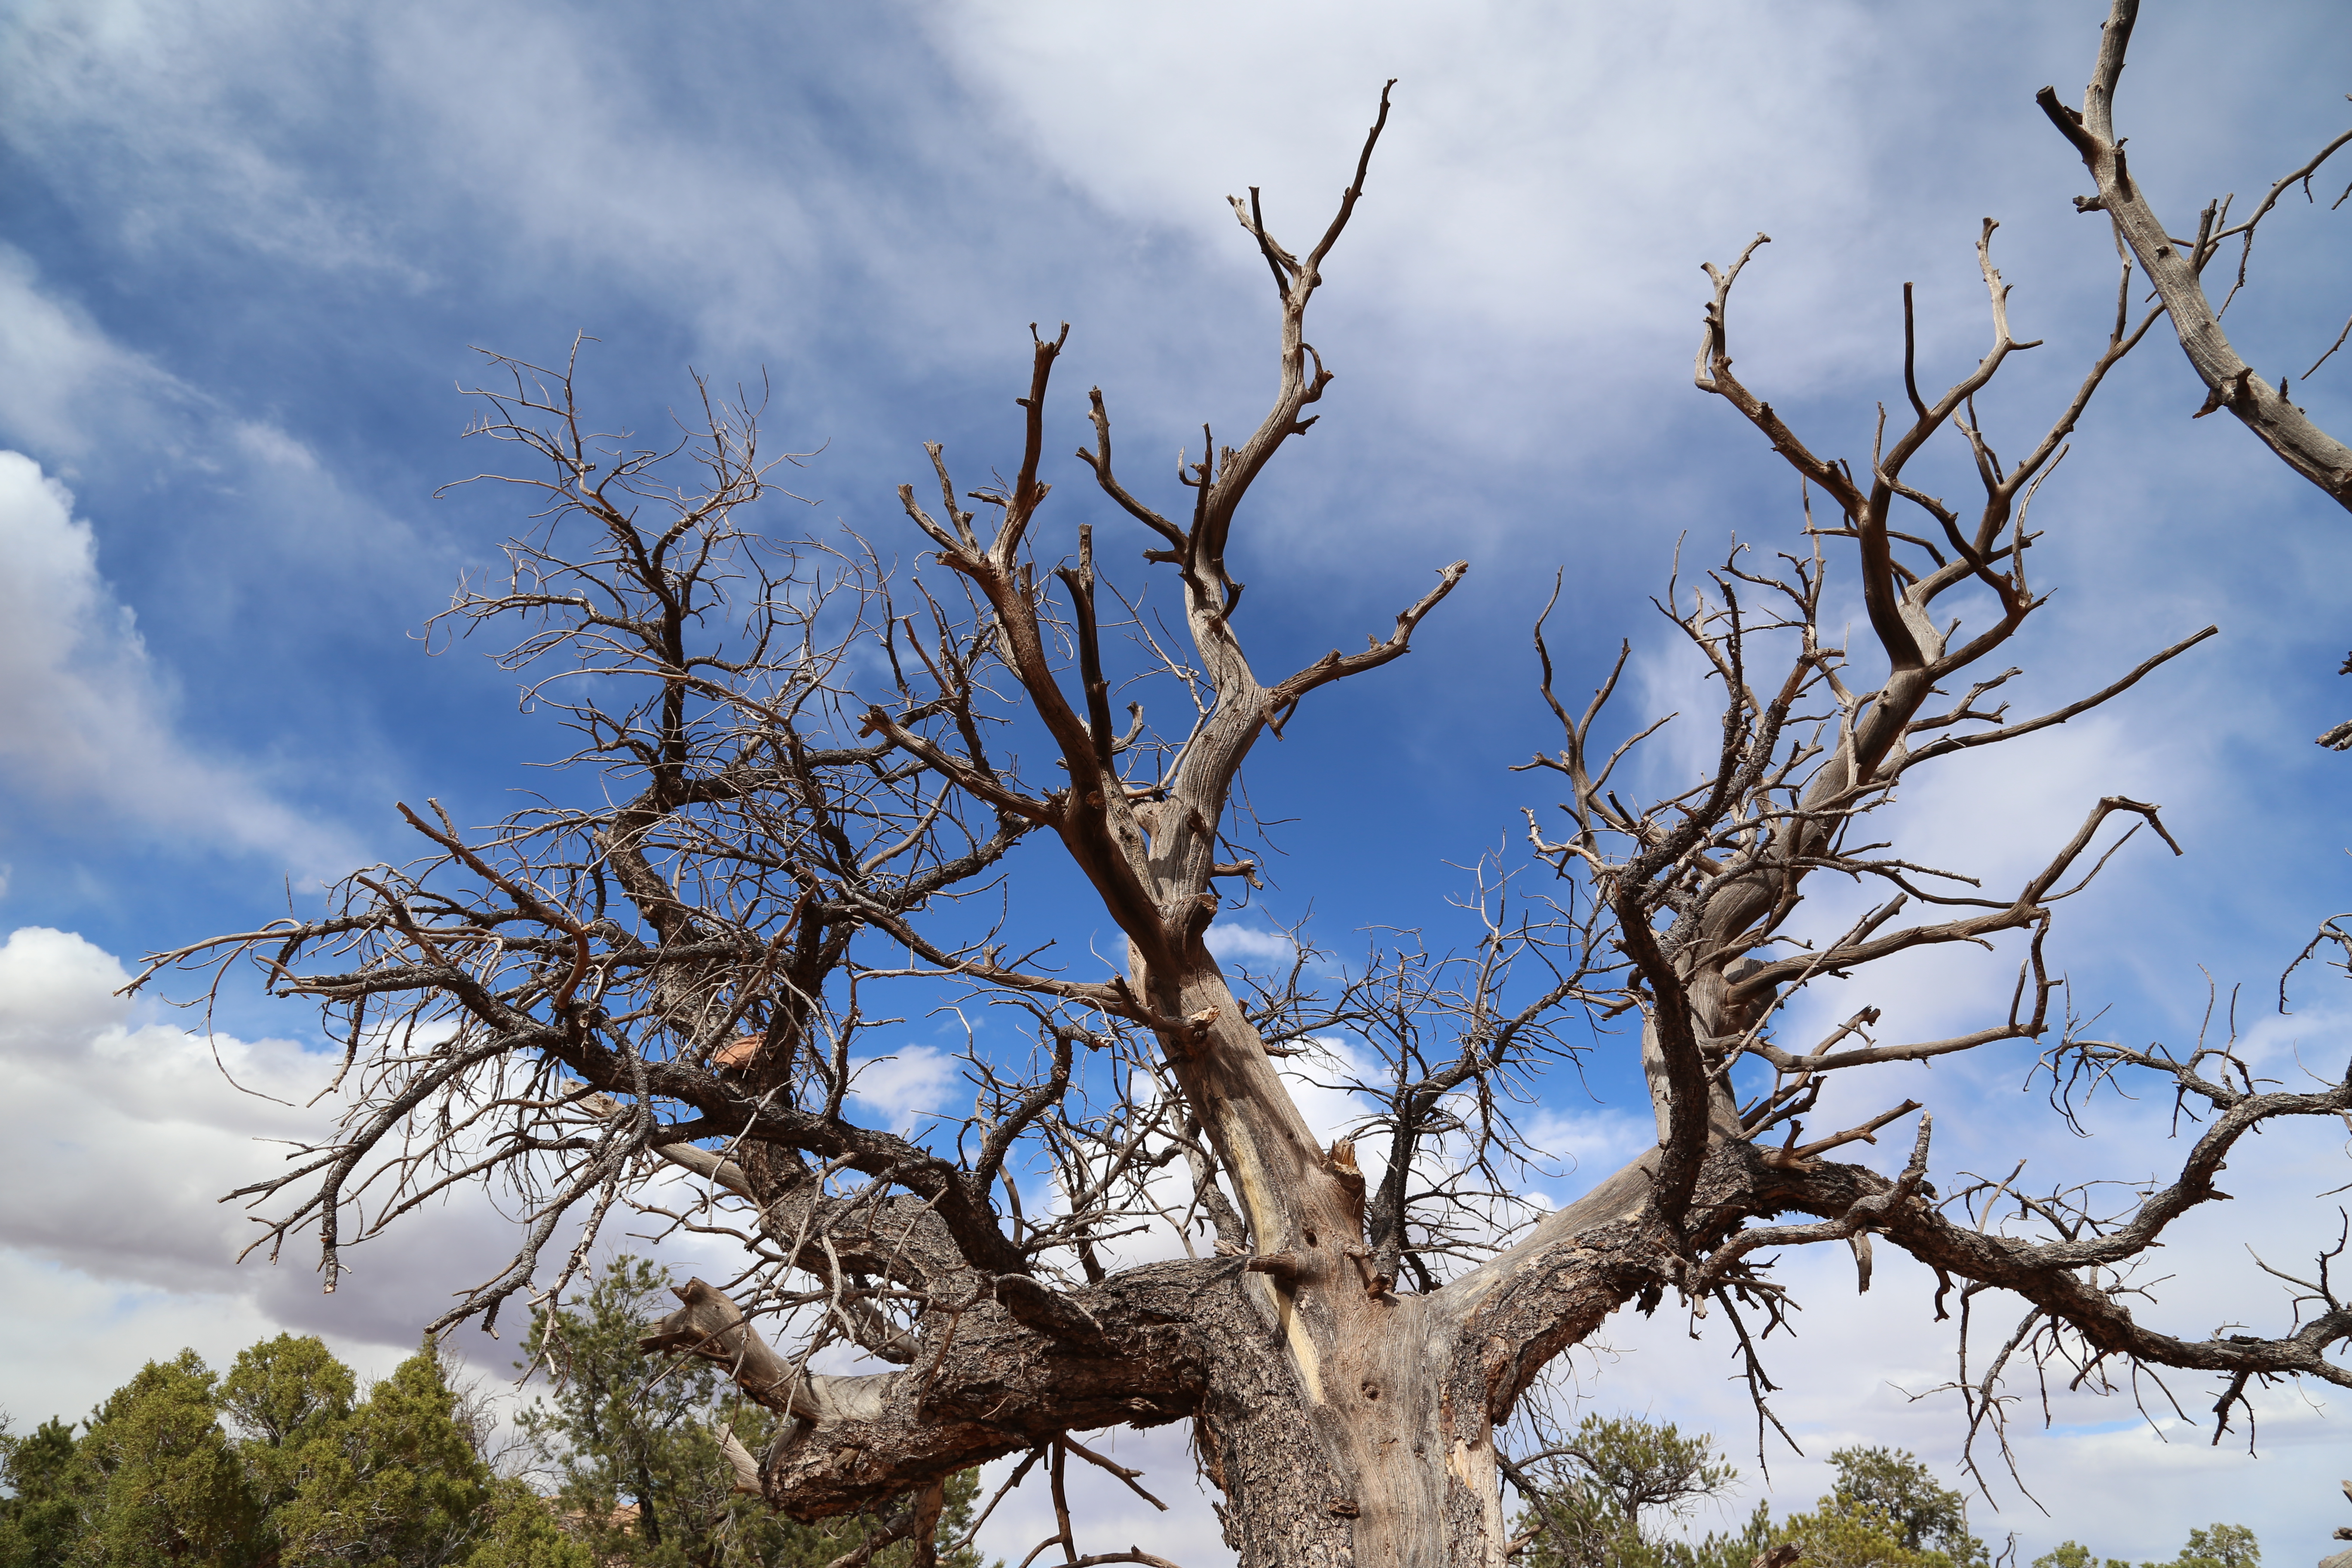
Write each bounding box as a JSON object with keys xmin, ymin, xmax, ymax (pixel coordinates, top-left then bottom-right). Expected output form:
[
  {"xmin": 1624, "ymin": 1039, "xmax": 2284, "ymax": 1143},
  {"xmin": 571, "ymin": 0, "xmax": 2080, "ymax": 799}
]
[{"xmin": 148, "ymin": 73, "xmax": 2352, "ymax": 1568}]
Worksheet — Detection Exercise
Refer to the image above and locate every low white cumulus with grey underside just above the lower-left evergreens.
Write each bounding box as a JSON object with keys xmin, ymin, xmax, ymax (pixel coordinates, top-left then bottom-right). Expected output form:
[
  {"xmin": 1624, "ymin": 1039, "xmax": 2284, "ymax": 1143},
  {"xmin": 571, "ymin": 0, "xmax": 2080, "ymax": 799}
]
[{"xmin": 0, "ymin": 926, "xmax": 583, "ymax": 1391}]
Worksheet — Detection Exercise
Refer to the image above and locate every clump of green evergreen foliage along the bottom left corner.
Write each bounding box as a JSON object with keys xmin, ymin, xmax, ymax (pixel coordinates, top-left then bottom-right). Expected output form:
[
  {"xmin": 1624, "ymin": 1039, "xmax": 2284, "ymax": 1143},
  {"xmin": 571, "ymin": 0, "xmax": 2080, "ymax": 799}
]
[{"xmin": 0, "ymin": 1258, "xmax": 981, "ymax": 1568}]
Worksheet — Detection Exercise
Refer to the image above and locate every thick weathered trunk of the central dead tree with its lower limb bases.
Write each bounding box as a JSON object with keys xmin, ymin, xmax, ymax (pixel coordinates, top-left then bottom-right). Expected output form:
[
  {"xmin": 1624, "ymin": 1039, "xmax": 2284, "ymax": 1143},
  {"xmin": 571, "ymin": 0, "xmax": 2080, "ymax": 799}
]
[{"xmin": 686, "ymin": 945, "xmax": 1712, "ymax": 1568}]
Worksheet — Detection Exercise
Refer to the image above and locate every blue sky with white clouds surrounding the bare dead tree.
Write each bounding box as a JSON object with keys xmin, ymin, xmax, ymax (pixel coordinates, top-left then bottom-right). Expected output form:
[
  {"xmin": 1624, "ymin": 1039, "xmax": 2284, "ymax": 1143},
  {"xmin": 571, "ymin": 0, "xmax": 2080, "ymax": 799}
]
[{"xmin": 0, "ymin": 0, "xmax": 2352, "ymax": 1563}]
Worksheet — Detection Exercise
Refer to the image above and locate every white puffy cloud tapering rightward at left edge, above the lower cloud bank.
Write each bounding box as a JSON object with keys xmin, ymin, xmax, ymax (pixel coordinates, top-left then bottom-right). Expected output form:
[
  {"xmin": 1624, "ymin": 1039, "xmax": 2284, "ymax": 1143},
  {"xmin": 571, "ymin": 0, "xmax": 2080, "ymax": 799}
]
[{"xmin": 0, "ymin": 451, "xmax": 355, "ymax": 872}]
